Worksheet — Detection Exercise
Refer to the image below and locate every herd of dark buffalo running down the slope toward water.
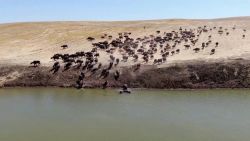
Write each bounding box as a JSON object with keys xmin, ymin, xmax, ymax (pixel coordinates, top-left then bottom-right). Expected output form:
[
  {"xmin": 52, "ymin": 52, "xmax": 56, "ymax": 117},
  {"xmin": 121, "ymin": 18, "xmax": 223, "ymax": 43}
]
[{"xmin": 31, "ymin": 26, "xmax": 246, "ymax": 89}]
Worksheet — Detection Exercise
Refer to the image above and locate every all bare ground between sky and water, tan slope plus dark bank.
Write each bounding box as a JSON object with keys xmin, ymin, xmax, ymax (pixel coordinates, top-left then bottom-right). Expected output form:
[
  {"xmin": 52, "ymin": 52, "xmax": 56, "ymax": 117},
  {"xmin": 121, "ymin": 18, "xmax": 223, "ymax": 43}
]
[{"xmin": 0, "ymin": 17, "xmax": 250, "ymax": 88}]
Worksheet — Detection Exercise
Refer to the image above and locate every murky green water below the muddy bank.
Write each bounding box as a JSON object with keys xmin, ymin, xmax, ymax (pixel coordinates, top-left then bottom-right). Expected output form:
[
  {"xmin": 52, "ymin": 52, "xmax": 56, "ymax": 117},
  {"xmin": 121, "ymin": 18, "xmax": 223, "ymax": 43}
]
[{"xmin": 0, "ymin": 88, "xmax": 250, "ymax": 141}]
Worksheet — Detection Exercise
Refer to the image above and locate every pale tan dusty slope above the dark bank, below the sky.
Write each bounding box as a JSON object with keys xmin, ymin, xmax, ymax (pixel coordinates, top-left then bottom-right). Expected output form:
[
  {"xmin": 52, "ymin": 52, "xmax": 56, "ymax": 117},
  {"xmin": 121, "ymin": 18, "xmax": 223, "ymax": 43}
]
[{"xmin": 0, "ymin": 17, "xmax": 250, "ymax": 66}]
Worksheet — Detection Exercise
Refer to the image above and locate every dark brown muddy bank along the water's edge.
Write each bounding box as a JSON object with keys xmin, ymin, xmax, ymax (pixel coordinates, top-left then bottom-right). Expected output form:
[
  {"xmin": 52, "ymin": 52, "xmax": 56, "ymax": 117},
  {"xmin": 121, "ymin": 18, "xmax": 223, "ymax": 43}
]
[{"xmin": 0, "ymin": 60, "xmax": 250, "ymax": 89}]
